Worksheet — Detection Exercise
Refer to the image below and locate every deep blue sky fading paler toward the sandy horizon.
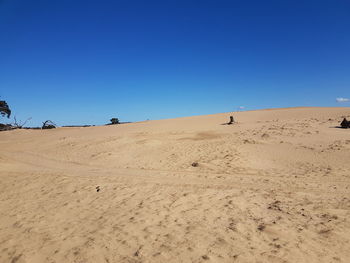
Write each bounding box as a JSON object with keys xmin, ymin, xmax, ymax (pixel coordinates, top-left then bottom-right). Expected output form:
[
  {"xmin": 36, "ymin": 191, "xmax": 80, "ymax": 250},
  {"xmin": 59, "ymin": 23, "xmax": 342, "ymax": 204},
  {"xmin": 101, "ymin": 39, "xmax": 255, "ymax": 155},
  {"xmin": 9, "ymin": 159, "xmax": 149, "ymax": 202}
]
[{"xmin": 0, "ymin": 0, "xmax": 350, "ymax": 125}]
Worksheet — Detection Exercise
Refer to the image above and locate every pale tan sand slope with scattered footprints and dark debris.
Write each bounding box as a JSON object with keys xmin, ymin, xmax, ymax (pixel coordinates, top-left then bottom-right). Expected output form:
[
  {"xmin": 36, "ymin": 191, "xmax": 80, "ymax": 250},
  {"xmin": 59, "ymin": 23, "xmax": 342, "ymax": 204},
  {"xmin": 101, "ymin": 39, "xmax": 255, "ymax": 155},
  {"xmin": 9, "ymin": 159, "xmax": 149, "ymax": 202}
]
[{"xmin": 0, "ymin": 108, "xmax": 350, "ymax": 263}]
